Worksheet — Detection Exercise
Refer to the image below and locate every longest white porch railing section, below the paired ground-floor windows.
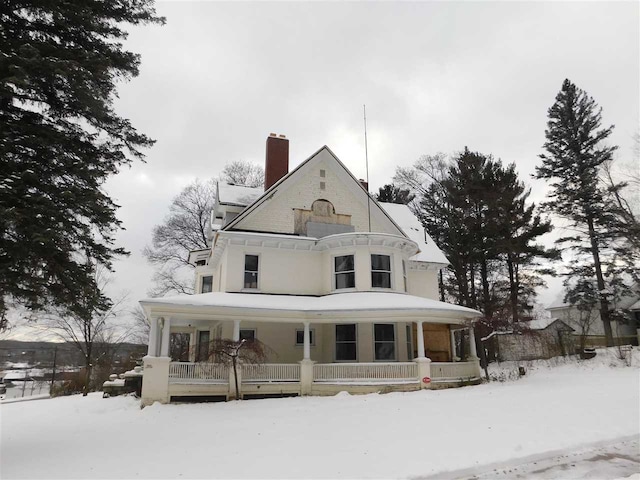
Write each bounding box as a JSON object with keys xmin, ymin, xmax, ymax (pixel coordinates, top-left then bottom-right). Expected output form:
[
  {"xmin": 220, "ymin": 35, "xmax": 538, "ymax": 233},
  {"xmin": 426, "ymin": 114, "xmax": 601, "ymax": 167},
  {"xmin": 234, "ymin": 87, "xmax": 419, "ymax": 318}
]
[{"xmin": 313, "ymin": 362, "xmax": 418, "ymax": 383}]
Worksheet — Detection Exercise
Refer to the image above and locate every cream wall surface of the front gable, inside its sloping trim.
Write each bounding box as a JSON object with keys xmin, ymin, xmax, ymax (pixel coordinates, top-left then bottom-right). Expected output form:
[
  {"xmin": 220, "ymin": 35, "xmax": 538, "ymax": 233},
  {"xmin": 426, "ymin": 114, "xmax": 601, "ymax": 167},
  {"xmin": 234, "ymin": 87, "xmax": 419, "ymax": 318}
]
[{"xmin": 234, "ymin": 151, "xmax": 398, "ymax": 235}]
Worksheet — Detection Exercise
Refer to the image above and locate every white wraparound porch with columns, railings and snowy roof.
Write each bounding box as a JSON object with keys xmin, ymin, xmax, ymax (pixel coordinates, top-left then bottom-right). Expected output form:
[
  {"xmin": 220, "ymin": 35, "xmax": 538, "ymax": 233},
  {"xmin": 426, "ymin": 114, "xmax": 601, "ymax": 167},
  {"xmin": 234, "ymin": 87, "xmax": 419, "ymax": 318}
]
[{"xmin": 141, "ymin": 292, "xmax": 480, "ymax": 404}]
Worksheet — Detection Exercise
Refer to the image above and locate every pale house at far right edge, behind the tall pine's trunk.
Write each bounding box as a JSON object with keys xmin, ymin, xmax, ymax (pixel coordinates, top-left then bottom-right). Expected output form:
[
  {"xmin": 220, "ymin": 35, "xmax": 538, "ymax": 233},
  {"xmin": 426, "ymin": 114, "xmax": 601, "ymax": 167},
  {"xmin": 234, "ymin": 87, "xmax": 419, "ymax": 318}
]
[{"xmin": 547, "ymin": 284, "xmax": 640, "ymax": 347}]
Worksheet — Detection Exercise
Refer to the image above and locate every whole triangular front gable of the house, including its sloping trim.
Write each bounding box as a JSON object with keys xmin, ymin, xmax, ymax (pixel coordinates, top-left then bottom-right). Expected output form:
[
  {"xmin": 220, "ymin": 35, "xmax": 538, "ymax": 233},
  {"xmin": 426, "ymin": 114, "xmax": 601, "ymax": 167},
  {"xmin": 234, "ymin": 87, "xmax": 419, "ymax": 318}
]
[{"xmin": 224, "ymin": 145, "xmax": 407, "ymax": 237}]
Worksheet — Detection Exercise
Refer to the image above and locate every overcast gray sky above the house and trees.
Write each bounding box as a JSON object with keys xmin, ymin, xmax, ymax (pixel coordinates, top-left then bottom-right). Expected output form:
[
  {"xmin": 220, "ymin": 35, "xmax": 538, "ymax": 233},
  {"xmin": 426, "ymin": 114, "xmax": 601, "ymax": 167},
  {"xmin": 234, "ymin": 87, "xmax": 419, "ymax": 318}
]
[{"xmin": 15, "ymin": 2, "xmax": 640, "ymax": 340}]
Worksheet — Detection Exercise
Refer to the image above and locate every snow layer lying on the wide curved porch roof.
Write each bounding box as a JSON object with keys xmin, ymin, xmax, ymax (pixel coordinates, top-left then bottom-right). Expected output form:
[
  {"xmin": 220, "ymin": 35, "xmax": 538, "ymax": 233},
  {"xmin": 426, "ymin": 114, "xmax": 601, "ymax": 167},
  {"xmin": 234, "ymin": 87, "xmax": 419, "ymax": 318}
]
[{"xmin": 140, "ymin": 292, "xmax": 481, "ymax": 318}]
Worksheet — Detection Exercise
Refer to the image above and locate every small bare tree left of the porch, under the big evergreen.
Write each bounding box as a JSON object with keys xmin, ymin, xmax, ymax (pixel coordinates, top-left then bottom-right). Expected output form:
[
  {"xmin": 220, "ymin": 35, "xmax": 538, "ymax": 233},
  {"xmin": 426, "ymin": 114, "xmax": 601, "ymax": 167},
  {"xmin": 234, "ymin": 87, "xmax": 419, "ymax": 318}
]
[{"xmin": 43, "ymin": 266, "xmax": 129, "ymax": 396}]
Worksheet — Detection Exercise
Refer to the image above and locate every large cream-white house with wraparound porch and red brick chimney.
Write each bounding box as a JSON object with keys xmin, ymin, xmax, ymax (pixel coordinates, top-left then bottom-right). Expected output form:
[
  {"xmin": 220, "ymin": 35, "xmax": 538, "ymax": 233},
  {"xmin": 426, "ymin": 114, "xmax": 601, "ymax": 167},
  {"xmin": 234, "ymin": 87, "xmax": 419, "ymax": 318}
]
[{"xmin": 140, "ymin": 134, "xmax": 480, "ymax": 404}]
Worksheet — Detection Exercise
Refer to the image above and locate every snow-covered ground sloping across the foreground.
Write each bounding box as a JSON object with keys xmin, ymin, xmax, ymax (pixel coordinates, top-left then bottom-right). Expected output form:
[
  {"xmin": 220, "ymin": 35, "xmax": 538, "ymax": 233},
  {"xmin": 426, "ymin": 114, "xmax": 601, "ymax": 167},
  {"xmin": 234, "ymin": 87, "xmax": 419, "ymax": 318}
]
[{"xmin": 0, "ymin": 349, "xmax": 640, "ymax": 479}]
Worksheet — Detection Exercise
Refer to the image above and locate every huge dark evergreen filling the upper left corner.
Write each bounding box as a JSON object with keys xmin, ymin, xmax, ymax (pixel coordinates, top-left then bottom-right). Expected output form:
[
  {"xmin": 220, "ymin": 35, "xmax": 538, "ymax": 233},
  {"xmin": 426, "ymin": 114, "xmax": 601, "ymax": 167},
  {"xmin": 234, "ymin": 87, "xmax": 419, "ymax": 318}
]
[{"xmin": 0, "ymin": 0, "xmax": 164, "ymax": 330}]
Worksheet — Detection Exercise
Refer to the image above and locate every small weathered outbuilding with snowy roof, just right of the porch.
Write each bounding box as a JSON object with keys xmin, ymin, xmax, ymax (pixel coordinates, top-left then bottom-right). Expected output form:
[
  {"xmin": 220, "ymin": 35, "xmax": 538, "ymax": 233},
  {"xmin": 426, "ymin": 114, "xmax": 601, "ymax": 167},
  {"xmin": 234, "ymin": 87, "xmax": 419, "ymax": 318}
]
[{"xmin": 483, "ymin": 318, "xmax": 576, "ymax": 362}]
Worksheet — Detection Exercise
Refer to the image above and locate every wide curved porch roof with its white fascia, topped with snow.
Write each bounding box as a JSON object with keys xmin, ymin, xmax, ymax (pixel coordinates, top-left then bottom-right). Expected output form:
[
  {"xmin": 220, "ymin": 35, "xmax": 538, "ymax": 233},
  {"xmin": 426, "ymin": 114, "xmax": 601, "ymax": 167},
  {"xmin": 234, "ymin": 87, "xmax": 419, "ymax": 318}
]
[{"xmin": 140, "ymin": 292, "xmax": 481, "ymax": 323}]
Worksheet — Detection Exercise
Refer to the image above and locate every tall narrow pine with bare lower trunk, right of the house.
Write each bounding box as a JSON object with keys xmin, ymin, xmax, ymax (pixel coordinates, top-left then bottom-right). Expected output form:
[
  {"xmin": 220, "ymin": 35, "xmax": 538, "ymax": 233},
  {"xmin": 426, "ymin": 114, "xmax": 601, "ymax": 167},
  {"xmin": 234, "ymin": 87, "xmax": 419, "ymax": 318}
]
[{"xmin": 536, "ymin": 80, "xmax": 617, "ymax": 346}]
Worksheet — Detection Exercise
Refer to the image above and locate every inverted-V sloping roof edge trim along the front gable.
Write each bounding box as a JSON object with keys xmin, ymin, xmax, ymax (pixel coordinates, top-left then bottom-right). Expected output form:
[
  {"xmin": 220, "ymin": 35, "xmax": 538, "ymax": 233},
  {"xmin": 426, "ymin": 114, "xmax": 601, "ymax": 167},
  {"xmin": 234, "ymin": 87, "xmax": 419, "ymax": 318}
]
[{"xmin": 222, "ymin": 145, "xmax": 407, "ymax": 236}]
